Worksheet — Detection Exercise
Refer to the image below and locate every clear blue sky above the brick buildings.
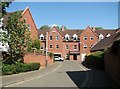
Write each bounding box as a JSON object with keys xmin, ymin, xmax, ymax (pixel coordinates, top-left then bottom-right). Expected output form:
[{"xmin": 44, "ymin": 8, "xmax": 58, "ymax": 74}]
[{"xmin": 7, "ymin": 2, "xmax": 118, "ymax": 29}]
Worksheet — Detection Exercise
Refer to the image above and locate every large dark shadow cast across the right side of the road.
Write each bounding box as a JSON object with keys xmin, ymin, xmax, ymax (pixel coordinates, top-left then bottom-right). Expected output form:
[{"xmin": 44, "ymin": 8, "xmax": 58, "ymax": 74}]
[{"xmin": 66, "ymin": 70, "xmax": 120, "ymax": 89}]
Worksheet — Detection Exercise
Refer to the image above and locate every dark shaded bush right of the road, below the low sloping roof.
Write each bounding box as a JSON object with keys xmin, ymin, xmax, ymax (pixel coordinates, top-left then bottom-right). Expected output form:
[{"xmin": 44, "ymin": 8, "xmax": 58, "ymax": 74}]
[{"xmin": 84, "ymin": 51, "xmax": 104, "ymax": 69}]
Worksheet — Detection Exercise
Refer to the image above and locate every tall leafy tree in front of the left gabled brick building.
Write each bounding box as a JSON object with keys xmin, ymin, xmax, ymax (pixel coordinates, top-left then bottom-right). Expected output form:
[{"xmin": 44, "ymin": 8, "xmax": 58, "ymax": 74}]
[{"xmin": 3, "ymin": 12, "xmax": 30, "ymax": 63}]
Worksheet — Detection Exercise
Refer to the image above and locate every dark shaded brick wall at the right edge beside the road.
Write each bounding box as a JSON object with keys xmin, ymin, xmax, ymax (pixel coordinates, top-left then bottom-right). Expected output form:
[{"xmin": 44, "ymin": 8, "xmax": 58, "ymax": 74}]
[{"xmin": 104, "ymin": 51, "xmax": 120, "ymax": 84}]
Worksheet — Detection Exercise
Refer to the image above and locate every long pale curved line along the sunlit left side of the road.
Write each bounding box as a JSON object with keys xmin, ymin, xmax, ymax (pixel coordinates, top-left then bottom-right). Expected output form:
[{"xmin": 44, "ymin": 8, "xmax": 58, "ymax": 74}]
[{"xmin": 3, "ymin": 63, "xmax": 63, "ymax": 87}]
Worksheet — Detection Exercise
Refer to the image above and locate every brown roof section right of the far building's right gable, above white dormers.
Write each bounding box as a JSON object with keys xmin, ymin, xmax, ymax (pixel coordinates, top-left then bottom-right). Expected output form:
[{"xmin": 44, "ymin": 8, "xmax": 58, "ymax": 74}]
[{"xmin": 95, "ymin": 29, "xmax": 116, "ymax": 36}]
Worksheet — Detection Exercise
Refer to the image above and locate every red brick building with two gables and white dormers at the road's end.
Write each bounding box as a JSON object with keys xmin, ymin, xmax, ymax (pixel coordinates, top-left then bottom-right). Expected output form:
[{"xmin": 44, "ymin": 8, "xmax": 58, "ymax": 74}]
[{"xmin": 38, "ymin": 26, "xmax": 116, "ymax": 60}]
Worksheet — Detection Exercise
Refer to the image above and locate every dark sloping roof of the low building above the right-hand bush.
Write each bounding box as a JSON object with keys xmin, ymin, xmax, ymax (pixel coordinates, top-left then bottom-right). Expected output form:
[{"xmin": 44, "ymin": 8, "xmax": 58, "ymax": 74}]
[{"xmin": 91, "ymin": 32, "xmax": 120, "ymax": 51}]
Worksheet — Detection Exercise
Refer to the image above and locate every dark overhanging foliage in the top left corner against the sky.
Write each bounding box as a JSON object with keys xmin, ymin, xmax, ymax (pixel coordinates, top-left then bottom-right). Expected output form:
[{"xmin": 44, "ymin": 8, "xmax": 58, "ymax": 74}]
[{"xmin": 0, "ymin": 2, "xmax": 11, "ymax": 18}]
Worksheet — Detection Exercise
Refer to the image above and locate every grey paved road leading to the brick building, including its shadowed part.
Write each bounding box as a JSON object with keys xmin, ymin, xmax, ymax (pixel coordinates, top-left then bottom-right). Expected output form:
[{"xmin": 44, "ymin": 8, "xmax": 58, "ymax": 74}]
[{"xmin": 2, "ymin": 61, "xmax": 120, "ymax": 89}]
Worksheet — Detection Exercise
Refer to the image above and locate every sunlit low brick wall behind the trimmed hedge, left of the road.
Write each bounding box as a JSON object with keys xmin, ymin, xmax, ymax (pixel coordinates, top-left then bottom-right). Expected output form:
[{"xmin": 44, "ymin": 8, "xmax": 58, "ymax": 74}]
[{"xmin": 23, "ymin": 53, "xmax": 53, "ymax": 66}]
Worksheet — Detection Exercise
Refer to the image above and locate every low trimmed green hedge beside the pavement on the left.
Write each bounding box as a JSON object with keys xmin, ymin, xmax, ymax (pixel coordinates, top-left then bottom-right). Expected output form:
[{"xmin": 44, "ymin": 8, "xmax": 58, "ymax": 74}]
[{"xmin": 2, "ymin": 62, "xmax": 40, "ymax": 75}]
